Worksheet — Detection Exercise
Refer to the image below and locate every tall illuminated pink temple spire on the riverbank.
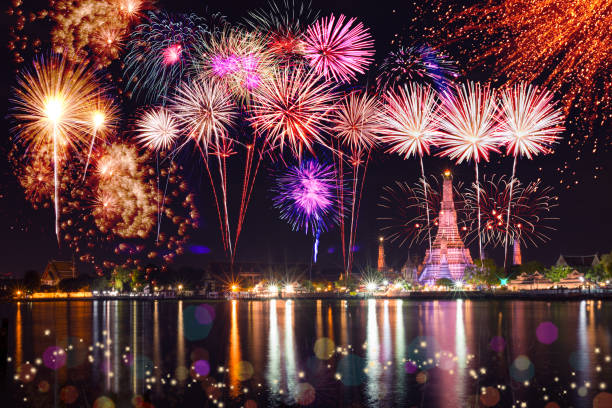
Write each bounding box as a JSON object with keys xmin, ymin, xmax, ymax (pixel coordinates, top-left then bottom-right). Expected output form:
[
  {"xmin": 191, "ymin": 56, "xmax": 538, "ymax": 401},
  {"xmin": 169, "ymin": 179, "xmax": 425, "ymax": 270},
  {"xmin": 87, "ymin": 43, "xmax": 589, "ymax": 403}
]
[{"xmin": 419, "ymin": 170, "xmax": 473, "ymax": 285}]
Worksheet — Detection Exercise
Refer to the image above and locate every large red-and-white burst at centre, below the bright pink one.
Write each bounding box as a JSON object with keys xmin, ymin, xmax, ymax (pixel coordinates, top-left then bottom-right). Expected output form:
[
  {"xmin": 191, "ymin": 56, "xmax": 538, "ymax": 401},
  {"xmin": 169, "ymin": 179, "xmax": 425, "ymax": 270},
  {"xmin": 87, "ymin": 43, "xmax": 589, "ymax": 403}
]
[{"xmin": 251, "ymin": 68, "xmax": 334, "ymax": 157}]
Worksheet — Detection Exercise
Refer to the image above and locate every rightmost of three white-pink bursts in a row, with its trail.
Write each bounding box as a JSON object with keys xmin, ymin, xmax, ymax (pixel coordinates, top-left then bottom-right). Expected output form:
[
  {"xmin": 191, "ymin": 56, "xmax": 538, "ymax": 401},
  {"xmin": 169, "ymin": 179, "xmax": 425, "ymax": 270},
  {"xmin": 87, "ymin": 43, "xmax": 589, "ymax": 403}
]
[{"xmin": 498, "ymin": 83, "xmax": 564, "ymax": 268}]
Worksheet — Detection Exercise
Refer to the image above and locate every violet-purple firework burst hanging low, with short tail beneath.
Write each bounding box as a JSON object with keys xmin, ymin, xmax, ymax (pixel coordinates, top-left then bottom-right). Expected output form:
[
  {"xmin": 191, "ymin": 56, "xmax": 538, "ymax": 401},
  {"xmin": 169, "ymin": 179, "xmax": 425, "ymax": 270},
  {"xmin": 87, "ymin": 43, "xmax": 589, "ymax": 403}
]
[{"xmin": 273, "ymin": 160, "xmax": 339, "ymax": 262}]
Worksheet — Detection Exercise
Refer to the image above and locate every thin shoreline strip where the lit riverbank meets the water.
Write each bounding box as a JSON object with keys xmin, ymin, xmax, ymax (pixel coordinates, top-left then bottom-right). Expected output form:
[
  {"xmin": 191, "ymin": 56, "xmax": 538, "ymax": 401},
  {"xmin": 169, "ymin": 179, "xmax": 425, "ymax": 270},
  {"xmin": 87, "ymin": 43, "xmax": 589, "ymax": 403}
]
[{"xmin": 0, "ymin": 291, "xmax": 612, "ymax": 303}]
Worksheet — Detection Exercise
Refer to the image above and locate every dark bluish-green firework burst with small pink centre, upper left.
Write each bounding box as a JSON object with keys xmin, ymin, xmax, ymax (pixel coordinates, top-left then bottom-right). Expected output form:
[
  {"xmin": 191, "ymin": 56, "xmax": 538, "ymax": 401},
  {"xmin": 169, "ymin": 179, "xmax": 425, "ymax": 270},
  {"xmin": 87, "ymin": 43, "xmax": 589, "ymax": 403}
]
[{"xmin": 123, "ymin": 11, "xmax": 208, "ymax": 102}]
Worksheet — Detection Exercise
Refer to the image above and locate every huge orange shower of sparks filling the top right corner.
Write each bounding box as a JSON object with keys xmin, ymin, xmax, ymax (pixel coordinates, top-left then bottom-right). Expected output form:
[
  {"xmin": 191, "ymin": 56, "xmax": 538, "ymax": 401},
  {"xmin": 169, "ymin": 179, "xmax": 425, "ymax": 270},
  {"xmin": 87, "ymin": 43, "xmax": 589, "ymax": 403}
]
[{"xmin": 447, "ymin": 0, "xmax": 612, "ymax": 135}]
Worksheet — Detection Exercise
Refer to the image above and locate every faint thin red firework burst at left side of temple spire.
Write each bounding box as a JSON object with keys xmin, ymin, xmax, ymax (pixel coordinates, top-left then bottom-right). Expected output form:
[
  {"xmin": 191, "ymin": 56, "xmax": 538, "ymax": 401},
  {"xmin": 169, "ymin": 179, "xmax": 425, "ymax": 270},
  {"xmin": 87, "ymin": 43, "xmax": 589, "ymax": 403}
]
[{"xmin": 378, "ymin": 176, "xmax": 469, "ymax": 247}]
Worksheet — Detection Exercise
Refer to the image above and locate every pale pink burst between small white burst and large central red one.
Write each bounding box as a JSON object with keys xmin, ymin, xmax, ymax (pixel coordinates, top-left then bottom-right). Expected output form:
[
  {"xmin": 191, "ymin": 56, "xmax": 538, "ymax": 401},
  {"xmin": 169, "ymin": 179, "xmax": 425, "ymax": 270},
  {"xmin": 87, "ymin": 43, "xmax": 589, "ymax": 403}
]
[{"xmin": 172, "ymin": 80, "xmax": 237, "ymax": 154}]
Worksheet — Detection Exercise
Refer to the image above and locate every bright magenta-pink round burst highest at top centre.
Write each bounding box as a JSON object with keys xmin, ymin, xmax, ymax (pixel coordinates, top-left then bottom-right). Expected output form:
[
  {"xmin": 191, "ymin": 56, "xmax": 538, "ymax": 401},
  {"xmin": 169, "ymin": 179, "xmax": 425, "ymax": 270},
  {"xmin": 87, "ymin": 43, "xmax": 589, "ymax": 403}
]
[{"xmin": 304, "ymin": 14, "xmax": 374, "ymax": 82}]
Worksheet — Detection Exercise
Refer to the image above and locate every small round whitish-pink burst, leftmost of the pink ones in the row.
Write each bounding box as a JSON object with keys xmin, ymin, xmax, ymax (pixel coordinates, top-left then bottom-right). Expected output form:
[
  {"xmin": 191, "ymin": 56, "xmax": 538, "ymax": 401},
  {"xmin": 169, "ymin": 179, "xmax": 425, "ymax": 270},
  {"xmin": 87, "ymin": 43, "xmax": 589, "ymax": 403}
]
[{"xmin": 136, "ymin": 107, "xmax": 179, "ymax": 151}]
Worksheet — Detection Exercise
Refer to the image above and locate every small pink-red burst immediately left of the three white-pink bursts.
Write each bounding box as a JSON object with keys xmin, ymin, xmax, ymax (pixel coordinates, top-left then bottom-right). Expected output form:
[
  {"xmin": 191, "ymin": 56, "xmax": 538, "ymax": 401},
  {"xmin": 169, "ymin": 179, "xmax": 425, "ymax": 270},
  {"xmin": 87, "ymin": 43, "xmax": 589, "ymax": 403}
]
[{"xmin": 331, "ymin": 92, "xmax": 384, "ymax": 151}]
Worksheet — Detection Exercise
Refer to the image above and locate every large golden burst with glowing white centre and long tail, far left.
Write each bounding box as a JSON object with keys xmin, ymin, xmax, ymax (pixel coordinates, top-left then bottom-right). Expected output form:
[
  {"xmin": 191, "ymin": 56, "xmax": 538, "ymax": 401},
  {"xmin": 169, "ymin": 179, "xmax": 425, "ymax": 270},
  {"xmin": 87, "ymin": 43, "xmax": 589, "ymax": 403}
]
[{"xmin": 10, "ymin": 55, "xmax": 100, "ymax": 244}]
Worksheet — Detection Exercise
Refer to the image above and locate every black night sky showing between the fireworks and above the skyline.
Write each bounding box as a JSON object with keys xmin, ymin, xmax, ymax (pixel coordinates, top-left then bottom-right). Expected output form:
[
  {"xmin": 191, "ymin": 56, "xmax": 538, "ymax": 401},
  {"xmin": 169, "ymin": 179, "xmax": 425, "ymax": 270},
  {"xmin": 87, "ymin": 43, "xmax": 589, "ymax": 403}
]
[{"xmin": 0, "ymin": 0, "xmax": 612, "ymax": 275}]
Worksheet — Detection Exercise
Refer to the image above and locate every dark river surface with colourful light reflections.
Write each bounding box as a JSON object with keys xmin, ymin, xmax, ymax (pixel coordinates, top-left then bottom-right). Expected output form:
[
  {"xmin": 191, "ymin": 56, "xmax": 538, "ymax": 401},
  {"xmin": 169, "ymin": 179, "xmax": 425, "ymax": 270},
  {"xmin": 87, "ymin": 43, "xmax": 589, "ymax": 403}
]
[{"xmin": 0, "ymin": 299, "xmax": 612, "ymax": 408}]
